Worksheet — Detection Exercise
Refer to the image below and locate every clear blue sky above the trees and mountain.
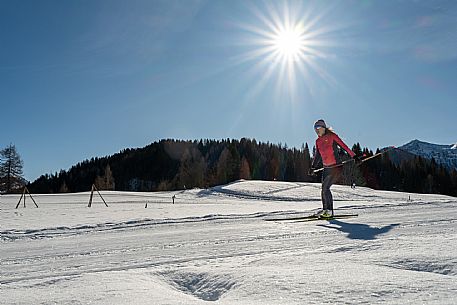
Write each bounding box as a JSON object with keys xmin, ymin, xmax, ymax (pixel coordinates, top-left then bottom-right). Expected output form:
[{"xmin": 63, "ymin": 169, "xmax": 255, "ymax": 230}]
[{"xmin": 0, "ymin": 0, "xmax": 457, "ymax": 180}]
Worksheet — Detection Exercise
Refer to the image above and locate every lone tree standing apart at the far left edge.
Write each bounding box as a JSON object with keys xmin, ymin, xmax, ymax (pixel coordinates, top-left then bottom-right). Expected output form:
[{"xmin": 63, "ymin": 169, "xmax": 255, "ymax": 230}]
[{"xmin": 0, "ymin": 144, "xmax": 25, "ymax": 193}]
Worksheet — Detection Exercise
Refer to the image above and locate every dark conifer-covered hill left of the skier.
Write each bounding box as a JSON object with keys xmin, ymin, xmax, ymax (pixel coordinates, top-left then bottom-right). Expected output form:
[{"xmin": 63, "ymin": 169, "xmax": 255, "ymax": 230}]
[{"xmin": 29, "ymin": 138, "xmax": 313, "ymax": 193}]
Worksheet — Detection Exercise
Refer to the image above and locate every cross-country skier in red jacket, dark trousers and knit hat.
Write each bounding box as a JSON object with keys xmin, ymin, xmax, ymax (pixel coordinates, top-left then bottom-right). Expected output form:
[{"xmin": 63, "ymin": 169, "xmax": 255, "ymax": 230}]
[{"xmin": 310, "ymin": 120, "xmax": 358, "ymax": 217}]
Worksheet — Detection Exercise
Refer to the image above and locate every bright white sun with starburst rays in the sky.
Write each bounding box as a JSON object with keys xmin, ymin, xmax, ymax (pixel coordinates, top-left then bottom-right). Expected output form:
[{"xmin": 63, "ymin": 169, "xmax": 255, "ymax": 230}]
[{"xmin": 233, "ymin": 1, "xmax": 340, "ymax": 102}]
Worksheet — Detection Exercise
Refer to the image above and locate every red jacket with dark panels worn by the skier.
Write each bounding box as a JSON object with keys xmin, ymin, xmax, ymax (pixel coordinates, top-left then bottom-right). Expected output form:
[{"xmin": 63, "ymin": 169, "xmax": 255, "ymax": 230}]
[{"xmin": 312, "ymin": 132, "xmax": 355, "ymax": 168}]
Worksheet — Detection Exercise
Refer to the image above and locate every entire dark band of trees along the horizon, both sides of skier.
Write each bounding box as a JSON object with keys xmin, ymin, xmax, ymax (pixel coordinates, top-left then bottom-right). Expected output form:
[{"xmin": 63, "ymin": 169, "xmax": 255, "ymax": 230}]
[{"xmin": 0, "ymin": 138, "xmax": 457, "ymax": 196}]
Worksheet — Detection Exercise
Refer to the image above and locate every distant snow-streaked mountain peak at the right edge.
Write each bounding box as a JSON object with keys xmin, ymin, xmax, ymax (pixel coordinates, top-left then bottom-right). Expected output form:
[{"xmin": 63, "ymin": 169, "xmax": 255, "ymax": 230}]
[{"xmin": 399, "ymin": 140, "xmax": 457, "ymax": 169}]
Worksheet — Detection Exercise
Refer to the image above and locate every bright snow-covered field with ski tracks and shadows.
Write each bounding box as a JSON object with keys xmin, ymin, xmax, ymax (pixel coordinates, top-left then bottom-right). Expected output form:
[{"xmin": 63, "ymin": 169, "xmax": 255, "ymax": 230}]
[{"xmin": 0, "ymin": 181, "xmax": 457, "ymax": 305}]
